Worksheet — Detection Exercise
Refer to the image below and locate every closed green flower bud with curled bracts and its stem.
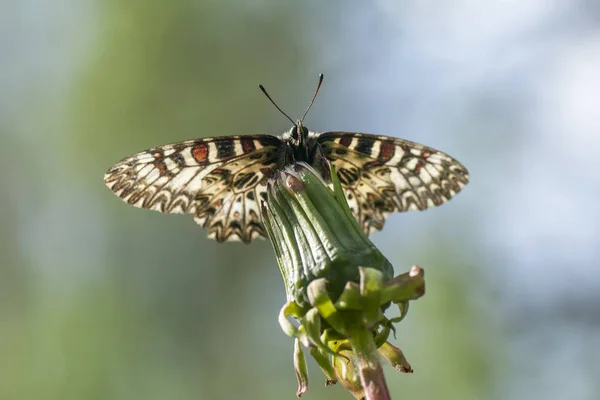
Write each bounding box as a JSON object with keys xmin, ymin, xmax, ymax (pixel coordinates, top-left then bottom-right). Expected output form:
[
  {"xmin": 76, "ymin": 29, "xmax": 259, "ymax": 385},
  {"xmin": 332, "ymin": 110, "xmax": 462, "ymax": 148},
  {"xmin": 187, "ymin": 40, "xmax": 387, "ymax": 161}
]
[{"xmin": 262, "ymin": 163, "xmax": 425, "ymax": 399}]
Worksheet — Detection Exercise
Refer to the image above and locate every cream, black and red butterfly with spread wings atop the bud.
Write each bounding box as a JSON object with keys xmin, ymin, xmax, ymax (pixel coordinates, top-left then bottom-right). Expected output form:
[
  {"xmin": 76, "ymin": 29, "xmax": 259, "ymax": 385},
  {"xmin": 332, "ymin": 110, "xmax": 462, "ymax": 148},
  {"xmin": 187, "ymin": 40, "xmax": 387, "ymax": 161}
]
[{"xmin": 104, "ymin": 74, "xmax": 469, "ymax": 243}]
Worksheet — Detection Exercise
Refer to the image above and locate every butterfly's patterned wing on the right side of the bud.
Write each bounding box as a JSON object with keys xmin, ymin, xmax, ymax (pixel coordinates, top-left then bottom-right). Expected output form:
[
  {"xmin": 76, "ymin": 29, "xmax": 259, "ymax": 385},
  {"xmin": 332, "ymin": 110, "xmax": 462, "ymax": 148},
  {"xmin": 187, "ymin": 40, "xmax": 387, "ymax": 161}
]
[{"xmin": 317, "ymin": 132, "xmax": 469, "ymax": 234}]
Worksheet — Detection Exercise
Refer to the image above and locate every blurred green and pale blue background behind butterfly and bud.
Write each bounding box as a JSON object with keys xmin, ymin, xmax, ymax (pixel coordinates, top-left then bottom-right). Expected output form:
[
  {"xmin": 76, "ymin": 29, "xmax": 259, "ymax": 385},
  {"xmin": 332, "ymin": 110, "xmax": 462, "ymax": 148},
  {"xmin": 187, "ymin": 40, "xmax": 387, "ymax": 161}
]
[{"xmin": 0, "ymin": 0, "xmax": 600, "ymax": 400}]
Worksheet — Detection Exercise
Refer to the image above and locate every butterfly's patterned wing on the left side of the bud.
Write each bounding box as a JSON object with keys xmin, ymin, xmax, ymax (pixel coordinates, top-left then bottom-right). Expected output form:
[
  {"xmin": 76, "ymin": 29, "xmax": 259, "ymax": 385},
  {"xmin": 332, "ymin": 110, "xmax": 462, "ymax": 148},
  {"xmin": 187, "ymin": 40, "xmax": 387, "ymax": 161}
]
[{"xmin": 104, "ymin": 135, "xmax": 282, "ymax": 243}]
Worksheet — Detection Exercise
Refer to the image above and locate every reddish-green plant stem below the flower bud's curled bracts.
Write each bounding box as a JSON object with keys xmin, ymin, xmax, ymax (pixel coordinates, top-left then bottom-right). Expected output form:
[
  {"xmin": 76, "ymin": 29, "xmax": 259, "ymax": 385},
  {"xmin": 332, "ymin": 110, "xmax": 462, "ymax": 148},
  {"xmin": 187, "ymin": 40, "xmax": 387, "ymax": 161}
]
[{"xmin": 347, "ymin": 314, "xmax": 391, "ymax": 400}]
